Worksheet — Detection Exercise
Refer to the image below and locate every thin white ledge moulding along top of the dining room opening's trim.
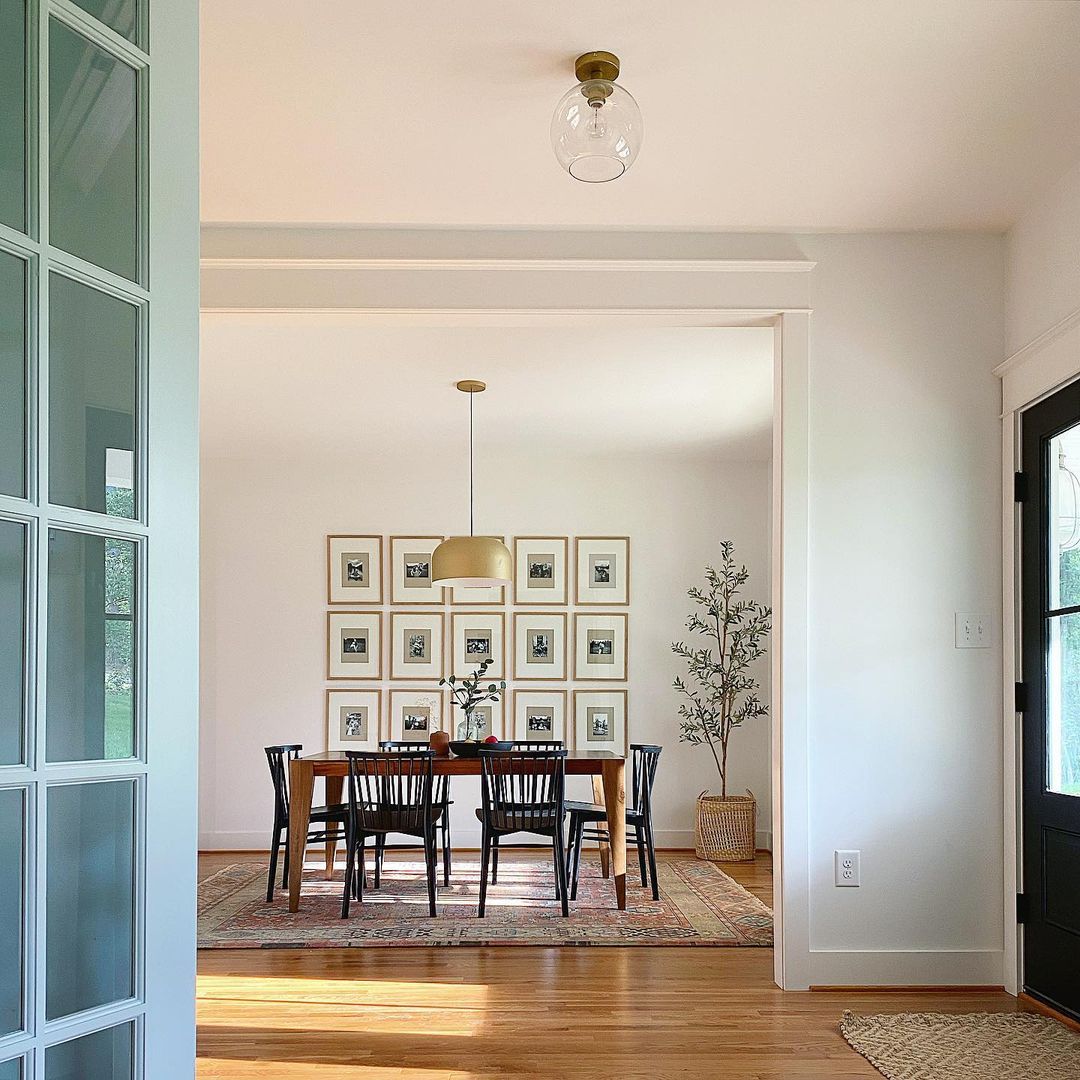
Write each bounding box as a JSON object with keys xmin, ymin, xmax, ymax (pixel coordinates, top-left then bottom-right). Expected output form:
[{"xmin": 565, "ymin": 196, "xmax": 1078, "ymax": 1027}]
[{"xmin": 200, "ymin": 256, "xmax": 818, "ymax": 273}]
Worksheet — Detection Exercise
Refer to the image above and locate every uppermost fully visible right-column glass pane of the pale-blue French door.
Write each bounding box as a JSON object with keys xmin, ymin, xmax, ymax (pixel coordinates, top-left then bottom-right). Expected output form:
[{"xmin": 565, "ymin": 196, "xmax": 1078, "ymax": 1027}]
[{"xmin": 49, "ymin": 19, "xmax": 137, "ymax": 280}]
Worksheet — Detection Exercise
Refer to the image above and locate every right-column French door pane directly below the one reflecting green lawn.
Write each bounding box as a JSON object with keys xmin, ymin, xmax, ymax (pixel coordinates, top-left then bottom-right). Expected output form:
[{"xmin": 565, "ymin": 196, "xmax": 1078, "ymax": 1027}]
[{"xmin": 45, "ymin": 780, "xmax": 135, "ymax": 1015}]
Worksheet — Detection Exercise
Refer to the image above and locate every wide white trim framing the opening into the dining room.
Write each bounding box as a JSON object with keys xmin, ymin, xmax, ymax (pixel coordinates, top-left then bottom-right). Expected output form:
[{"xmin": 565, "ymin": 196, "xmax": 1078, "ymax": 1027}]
[{"xmin": 202, "ymin": 250, "xmax": 815, "ymax": 989}]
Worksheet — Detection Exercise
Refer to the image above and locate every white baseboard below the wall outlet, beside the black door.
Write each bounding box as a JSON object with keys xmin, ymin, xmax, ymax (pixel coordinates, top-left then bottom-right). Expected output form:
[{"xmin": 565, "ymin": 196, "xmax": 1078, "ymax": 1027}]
[{"xmin": 809, "ymin": 949, "xmax": 1004, "ymax": 987}]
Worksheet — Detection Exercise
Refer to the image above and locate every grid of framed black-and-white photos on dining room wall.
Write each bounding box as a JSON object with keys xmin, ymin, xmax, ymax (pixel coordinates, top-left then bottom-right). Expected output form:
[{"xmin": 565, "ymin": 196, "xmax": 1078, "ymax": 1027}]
[{"xmin": 325, "ymin": 534, "xmax": 632, "ymax": 754}]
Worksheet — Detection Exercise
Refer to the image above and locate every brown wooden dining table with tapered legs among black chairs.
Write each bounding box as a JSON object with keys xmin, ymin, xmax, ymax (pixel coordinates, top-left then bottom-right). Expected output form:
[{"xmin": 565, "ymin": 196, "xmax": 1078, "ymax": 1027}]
[{"xmin": 288, "ymin": 750, "xmax": 626, "ymax": 912}]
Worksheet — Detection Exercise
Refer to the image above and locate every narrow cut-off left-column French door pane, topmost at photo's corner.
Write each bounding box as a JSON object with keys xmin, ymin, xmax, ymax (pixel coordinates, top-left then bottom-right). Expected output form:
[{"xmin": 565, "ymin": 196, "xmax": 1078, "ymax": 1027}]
[{"xmin": 0, "ymin": 0, "xmax": 26, "ymax": 232}]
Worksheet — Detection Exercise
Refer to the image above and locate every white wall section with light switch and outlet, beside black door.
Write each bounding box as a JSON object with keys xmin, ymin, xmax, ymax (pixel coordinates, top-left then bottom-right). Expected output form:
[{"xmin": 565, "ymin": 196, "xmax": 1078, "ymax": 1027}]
[{"xmin": 802, "ymin": 235, "xmax": 1003, "ymax": 984}]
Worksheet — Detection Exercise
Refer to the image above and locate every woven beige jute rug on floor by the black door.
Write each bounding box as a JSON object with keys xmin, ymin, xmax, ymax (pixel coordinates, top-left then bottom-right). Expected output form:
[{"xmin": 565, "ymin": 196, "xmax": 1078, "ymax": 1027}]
[{"xmin": 840, "ymin": 1012, "xmax": 1080, "ymax": 1080}]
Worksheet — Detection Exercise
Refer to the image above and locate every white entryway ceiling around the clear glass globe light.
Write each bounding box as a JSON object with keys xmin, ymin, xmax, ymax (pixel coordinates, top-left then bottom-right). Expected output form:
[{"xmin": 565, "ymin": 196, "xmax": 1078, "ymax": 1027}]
[{"xmin": 202, "ymin": 0, "xmax": 1080, "ymax": 231}]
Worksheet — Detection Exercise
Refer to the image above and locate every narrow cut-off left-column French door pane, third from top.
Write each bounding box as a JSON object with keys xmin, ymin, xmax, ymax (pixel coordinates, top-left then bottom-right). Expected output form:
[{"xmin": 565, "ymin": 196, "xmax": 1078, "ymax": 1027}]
[{"xmin": 0, "ymin": 518, "xmax": 28, "ymax": 764}]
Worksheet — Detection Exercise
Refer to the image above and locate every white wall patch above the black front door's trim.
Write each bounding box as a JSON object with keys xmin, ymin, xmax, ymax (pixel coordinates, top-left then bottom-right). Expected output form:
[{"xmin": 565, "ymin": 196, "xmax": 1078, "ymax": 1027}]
[{"xmin": 1005, "ymin": 157, "xmax": 1080, "ymax": 354}]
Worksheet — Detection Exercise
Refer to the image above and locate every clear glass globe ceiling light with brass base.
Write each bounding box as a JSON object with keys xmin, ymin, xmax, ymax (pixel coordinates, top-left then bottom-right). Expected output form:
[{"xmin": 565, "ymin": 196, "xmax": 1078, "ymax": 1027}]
[{"xmin": 551, "ymin": 52, "xmax": 643, "ymax": 184}]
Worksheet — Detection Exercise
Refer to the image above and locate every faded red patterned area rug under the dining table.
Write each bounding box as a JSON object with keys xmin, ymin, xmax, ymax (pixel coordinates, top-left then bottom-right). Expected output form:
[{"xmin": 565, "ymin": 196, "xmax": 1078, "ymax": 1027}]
[{"xmin": 199, "ymin": 852, "xmax": 772, "ymax": 948}]
